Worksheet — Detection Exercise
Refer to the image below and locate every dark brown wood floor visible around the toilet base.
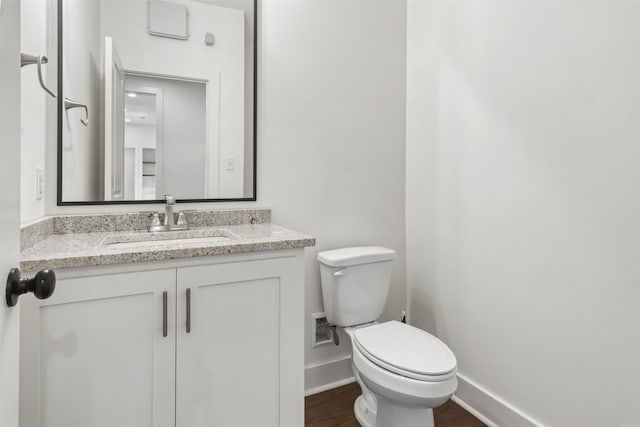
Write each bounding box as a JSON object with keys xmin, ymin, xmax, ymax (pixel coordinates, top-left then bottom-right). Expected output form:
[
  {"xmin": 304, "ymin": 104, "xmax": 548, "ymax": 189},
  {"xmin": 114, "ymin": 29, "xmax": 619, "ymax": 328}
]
[{"xmin": 304, "ymin": 383, "xmax": 485, "ymax": 427}]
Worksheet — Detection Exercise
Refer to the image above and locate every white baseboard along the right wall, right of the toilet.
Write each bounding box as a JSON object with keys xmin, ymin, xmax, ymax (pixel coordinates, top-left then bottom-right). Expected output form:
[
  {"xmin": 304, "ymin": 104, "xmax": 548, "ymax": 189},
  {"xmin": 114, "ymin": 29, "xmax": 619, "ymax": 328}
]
[{"xmin": 451, "ymin": 373, "xmax": 544, "ymax": 427}]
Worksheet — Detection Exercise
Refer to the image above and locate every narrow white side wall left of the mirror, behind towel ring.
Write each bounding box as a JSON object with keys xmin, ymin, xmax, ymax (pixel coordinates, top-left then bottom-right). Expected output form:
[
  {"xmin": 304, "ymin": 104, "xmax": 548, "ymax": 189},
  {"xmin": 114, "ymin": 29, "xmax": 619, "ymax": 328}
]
[{"xmin": 20, "ymin": 0, "xmax": 48, "ymax": 224}]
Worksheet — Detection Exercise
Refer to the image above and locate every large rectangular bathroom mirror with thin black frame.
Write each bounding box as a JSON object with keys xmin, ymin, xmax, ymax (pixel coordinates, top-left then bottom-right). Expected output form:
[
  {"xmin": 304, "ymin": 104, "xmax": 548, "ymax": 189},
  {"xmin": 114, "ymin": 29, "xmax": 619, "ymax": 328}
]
[{"xmin": 58, "ymin": 0, "xmax": 257, "ymax": 205}]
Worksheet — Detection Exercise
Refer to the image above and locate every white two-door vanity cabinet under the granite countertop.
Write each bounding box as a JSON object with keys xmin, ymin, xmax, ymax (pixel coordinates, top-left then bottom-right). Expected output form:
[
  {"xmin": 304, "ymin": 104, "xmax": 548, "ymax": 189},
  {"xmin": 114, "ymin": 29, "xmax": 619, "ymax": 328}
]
[{"xmin": 20, "ymin": 249, "xmax": 304, "ymax": 427}]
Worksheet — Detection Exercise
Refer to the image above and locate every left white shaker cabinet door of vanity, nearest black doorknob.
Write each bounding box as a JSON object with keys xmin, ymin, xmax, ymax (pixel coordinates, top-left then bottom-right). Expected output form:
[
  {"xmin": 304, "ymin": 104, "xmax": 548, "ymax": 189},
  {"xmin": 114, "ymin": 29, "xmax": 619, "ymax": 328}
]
[{"xmin": 21, "ymin": 269, "xmax": 176, "ymax": 427}]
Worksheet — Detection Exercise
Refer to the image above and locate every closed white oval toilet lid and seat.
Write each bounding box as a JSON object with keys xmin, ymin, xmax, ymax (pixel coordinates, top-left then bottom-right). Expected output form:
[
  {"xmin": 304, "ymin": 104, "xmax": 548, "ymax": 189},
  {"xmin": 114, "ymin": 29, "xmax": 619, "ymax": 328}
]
[{"xmin": 353, "ymin": 321, "xmax": 457, "ymax": 382}]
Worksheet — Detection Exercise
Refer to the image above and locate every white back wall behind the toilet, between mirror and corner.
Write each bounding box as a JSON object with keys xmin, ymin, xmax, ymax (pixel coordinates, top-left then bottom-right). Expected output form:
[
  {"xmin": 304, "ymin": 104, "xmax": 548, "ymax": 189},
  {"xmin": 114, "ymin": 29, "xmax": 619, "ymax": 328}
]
[{"xmin": 258, "ymin": 0, "xmax": 406, "ymax": 387}]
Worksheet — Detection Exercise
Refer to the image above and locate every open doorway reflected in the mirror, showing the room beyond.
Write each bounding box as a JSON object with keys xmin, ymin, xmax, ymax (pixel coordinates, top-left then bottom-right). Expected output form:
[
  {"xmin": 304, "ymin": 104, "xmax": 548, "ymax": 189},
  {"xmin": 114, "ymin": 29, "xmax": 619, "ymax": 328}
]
[{"xmin": 124, "ymin": 72, "xmax": 208, "ymax": 200}]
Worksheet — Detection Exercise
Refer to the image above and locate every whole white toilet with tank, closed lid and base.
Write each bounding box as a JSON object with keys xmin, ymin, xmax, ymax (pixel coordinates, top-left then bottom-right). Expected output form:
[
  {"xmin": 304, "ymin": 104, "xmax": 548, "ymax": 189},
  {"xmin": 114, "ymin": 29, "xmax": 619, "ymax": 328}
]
[{"xmin": 318, "ymin": 246, "xmax": 458, "ymax": 427}]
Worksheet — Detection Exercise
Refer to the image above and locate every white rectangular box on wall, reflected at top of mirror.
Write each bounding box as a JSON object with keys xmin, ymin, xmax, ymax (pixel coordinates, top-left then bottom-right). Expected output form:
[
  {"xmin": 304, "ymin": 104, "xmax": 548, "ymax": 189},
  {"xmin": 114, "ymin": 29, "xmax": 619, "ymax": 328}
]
[{"xmin": 147, "ymin": 0, "xmax": 189, "ymax": 40}]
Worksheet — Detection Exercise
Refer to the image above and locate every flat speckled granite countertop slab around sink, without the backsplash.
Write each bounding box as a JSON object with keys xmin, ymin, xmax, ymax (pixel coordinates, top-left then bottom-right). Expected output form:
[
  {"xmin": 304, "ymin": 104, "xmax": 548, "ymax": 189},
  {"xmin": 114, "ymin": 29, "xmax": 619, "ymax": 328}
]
[{"xmin": 20, "ymin": 210, "xmax": 315, "ymax": 271}]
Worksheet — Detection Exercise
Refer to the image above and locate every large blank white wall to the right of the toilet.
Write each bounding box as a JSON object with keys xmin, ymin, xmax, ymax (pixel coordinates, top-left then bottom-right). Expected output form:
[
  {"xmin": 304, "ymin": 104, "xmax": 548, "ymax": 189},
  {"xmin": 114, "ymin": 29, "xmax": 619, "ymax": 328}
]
[{"xmin": 406, "ymin": 0, "xmax": 640, "ymax": 427}]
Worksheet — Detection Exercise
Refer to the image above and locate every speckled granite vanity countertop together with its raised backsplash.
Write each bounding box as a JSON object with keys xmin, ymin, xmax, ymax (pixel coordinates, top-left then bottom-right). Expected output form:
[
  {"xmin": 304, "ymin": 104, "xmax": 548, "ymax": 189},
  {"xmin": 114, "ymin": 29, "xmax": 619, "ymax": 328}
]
[{"xmin": 20, "ymin": 209, "xmax": 315, "ymax": 272}]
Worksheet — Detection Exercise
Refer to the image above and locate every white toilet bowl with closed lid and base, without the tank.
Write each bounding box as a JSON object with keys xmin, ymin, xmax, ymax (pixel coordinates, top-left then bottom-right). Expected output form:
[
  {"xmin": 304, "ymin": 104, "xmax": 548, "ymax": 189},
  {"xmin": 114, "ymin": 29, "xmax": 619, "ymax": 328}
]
[{"xmin": 350, "ymin": 321, "xmax": 458, "ymax": 427}]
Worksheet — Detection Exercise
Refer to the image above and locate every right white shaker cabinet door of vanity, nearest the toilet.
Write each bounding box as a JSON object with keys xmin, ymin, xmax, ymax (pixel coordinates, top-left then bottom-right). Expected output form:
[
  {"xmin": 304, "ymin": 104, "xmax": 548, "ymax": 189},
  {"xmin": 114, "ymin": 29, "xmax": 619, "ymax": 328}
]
[{"xmin": 176, "ymin": 257, "xmax": 304, "ymax": 427}]
